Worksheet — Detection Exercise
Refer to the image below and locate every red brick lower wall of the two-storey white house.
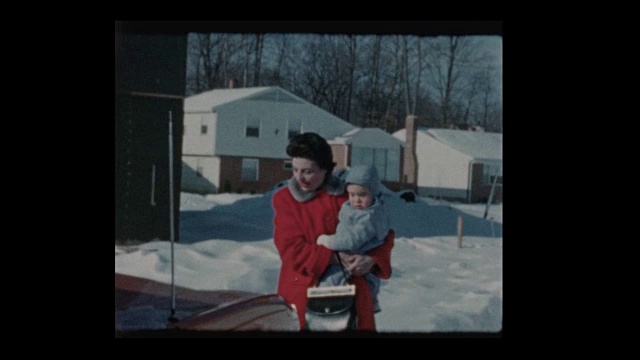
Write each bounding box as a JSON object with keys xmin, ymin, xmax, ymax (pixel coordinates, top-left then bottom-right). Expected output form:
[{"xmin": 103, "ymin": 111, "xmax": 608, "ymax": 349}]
[{"xmin": 219, "ymin": 156, "xmax": 291, "ymax": 193}]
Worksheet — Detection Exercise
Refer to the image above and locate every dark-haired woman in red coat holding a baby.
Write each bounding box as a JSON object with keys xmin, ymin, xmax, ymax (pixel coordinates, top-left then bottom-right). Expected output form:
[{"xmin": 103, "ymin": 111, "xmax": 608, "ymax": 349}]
[{"xmin": 272, "ymin": 133, "xmax": 394, "ymax": 331}]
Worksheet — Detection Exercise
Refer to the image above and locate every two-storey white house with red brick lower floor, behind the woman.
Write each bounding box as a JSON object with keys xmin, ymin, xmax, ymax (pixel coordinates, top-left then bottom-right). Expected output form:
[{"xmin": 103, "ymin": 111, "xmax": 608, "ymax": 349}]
[{"xmin": 182, "ymin": 86, "xmax": 402, "ymax": 193}]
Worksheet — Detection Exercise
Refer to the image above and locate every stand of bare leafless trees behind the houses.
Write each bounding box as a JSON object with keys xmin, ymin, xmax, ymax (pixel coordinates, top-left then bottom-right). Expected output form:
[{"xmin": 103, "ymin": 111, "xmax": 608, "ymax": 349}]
[{"xmin": 187, "ymin": 34, "xmax": 501, "ymax": 132}]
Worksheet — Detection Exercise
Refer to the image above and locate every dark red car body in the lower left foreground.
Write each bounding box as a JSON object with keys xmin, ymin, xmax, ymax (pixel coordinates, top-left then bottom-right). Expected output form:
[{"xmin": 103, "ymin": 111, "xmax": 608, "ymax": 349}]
[{"xmin": 115, "ymin": 273, "xmax": 299, "ymax": 337}]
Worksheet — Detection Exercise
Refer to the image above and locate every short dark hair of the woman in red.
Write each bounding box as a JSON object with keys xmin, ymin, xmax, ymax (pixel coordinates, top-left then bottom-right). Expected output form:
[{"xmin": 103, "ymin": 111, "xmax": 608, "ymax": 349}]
[{"xmin": 287, "ymin": 133, "xmax": 336, "ymax": 175}]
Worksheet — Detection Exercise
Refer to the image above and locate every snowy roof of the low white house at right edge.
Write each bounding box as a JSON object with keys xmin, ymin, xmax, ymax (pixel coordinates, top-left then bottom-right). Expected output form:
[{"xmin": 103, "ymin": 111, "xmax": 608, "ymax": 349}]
[{"xmin": 418, "ymin": 127, "xmax": 502, "ymax": 160}]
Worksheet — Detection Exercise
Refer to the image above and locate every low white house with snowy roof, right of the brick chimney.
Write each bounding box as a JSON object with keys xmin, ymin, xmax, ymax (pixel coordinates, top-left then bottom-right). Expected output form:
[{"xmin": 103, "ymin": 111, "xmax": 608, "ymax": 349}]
[{"xmin": 393, "ymin": 126, "xmax": 502, "ymax": 203}]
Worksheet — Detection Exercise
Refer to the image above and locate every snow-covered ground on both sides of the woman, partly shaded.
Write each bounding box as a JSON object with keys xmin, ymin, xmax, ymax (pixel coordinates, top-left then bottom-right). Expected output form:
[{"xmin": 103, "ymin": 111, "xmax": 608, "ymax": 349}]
[{"xmin": 115, "ymin": 189, "xmax": 503, "ymax": 334}]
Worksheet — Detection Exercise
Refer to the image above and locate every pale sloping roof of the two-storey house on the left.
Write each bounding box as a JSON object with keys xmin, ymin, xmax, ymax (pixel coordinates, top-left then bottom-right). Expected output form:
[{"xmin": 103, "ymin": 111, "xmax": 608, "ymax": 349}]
[{"xmin": 184, "ymin": 86, "xmax": 279, "ymax": 112}]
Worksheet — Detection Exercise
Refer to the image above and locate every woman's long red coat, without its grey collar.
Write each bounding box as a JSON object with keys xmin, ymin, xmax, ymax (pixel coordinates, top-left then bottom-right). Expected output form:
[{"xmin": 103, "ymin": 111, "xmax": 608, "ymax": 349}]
[{"xmin": 273, "ymin": 187, "xmax": 394, "ymax": 331}]
